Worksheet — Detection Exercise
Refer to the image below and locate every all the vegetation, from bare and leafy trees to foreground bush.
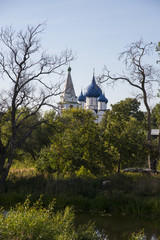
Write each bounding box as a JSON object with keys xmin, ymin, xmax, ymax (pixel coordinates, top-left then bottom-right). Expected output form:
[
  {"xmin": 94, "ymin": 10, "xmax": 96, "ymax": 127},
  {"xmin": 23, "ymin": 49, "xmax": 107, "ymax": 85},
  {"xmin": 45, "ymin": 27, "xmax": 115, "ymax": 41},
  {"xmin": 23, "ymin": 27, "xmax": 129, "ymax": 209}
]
[{"xmin": 0, "ymin": 32, "xmax": 160, "ymax": 240}]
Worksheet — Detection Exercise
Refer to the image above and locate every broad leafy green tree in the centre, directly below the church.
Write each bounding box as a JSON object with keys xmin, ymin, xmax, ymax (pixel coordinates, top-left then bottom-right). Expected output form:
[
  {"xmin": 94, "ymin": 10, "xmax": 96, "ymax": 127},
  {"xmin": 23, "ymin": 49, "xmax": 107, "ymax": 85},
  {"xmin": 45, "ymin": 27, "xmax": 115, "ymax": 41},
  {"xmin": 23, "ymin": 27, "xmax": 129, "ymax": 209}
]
[{"xmin": 38, "ymin": 109, "xmax": 115, "ymax": 176}]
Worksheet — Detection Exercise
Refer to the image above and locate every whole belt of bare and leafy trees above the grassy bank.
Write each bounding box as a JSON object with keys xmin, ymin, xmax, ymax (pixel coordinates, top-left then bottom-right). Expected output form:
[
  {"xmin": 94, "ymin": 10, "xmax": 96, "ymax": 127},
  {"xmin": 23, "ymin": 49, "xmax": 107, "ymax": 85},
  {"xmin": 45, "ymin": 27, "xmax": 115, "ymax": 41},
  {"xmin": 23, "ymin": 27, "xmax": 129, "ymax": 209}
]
[{"xmin": 0, "ymin": 28, "xmax": 160, "ymax": 183}]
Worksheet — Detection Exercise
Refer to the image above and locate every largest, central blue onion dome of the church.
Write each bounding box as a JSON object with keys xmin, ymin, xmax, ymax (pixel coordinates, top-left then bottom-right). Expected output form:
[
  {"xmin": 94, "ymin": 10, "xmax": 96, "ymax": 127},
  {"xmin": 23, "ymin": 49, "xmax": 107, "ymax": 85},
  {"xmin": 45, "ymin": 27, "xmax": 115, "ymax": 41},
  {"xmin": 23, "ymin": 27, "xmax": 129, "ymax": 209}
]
[{"xmin": 84, "ymin": 76, "xmax": 102, "ymax": 98}]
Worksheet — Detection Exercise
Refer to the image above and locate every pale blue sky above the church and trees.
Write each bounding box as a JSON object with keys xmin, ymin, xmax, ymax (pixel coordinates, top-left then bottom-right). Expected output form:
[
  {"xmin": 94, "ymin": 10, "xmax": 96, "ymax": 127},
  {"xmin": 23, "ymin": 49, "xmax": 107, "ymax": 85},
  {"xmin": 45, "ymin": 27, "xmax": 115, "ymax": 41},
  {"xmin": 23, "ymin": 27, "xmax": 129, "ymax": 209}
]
[{"xmin": 0, "ymin": 0, "xmax": 160, "ymax": 107}]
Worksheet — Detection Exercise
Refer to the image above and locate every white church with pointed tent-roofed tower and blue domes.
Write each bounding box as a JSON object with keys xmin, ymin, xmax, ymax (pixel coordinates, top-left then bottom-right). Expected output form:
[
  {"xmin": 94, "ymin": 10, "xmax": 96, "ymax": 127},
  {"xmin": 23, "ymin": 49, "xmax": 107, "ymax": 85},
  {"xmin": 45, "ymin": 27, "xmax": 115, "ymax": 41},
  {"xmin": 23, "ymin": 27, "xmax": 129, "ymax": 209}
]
[{"xmin": 58, "ymin": 67, "xmax": 108, "ymax": 123}]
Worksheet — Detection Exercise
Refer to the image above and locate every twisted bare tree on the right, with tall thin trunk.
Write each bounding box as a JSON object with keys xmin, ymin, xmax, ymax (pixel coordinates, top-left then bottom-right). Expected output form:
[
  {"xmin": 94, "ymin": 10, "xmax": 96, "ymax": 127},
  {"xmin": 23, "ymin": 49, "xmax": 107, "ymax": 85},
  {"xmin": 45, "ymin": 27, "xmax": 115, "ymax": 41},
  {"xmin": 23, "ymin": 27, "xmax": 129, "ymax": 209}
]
[{"xmin": 99, "ymin": 39, "xmax": 159, "ymax": 169}]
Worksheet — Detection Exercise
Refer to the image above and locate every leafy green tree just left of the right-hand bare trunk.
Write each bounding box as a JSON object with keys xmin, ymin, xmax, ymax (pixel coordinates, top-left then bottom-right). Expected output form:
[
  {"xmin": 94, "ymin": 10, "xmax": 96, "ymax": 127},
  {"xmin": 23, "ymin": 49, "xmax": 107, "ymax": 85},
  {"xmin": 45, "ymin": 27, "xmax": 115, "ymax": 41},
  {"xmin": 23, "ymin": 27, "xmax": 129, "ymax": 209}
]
[{"xmin": 103, "ymin": 99, "xmax": 146, "ymax": 172}]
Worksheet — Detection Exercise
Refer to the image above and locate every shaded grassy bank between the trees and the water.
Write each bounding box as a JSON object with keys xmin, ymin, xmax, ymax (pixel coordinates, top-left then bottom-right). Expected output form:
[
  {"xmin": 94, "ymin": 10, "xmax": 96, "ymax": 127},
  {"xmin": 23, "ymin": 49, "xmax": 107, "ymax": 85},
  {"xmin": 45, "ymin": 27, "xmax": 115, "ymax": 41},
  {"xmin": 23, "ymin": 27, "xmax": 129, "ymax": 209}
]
[{"xmin": 0, "ymin": 168, "xmax": 160, "ymax": 218}]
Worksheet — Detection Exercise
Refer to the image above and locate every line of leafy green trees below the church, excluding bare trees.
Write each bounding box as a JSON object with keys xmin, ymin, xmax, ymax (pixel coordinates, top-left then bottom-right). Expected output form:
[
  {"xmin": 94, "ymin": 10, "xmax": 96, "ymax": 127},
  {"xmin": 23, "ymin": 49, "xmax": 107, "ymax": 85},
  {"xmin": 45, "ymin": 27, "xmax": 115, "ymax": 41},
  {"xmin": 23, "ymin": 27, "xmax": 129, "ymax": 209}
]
[{"xmin": 8, "ymin": 98, "xmax": 160, "ymax": 178}]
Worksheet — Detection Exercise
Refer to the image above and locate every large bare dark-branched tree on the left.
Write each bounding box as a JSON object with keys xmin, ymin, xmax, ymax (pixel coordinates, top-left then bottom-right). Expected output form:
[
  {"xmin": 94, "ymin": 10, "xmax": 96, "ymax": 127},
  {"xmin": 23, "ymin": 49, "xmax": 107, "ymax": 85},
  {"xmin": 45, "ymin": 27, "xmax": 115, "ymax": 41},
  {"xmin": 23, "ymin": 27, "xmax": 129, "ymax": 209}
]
[{"xmin": 0, "ymin": 24, "xmax": 73, "ymax": 187}]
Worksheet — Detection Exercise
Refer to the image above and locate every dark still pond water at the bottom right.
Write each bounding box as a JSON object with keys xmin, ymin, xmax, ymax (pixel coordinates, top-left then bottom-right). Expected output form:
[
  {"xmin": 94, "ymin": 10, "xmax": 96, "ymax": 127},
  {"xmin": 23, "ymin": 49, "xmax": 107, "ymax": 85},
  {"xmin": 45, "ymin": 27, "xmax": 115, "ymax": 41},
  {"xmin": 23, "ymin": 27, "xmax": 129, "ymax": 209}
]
[{"xmin": 76, "ymin": 213, "xmax": 160, "ymax": 240}]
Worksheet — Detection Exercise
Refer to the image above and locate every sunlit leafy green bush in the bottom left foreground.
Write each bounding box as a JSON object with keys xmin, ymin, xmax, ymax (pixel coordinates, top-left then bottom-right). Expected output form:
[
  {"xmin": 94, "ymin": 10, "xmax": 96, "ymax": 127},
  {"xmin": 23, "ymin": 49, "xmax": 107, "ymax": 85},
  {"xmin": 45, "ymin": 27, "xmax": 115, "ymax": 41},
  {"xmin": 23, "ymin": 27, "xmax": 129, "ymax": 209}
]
[{"xmin": 0, "ymin": 198, "xmax": 98, "ymax": 240}]
